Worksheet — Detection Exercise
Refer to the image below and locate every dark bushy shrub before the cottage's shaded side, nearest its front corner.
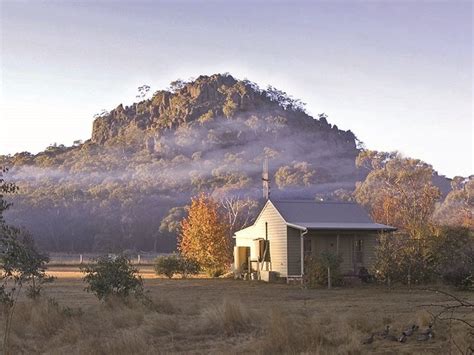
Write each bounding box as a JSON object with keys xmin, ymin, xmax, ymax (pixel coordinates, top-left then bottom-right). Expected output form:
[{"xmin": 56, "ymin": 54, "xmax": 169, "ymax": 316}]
[{"xmin": 305, "ymin": 251, "xmax": 342, "ymax": 287}]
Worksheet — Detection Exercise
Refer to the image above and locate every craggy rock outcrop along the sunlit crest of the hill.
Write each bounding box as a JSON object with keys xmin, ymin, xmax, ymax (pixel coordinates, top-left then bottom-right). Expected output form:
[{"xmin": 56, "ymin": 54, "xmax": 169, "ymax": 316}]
[{"xmin": 92, "ymin": 74, "xmax": 344, "ymax": 145}]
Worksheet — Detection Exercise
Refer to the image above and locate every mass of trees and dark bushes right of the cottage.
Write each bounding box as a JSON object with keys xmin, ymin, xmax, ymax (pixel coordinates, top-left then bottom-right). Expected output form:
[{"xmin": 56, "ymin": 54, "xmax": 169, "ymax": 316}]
[{"xmin": 353, "ymin": 151, "xmax": 474, "ymax": 289}]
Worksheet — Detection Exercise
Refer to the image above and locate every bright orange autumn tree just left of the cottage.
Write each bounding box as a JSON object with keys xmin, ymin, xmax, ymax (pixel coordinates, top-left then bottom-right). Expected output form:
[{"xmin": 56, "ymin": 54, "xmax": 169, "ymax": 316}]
[{"xmin": 178, "ymin": 194, "xmax": 232, "ymax": 275}]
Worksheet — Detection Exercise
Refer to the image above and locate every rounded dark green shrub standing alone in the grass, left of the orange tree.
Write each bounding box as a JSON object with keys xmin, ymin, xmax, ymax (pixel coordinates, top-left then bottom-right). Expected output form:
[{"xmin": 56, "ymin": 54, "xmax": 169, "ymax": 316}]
[{"xmin": 81, "ymin": 255, "xmax": 143, "ymax": 300}]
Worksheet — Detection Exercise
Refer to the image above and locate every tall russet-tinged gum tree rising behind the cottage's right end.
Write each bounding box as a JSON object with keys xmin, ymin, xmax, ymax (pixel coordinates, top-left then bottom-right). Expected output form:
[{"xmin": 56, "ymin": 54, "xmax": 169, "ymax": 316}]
[{"xmin": 355, "ymin": 151, "xmax": 440, "ymax": 239}]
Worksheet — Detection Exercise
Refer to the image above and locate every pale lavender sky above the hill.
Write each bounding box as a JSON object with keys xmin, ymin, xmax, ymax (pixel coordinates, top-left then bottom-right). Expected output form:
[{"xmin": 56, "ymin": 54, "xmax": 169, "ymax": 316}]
[{"xmin": 0, "ymin": 0, "xmax": 474, "ymax": 177}]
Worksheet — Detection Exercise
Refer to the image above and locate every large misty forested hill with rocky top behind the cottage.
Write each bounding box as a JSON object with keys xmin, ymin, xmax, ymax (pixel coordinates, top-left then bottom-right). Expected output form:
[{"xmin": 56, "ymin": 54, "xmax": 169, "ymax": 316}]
[{"xmin": 0, "ymin": 75, "xmax": 460, "ymax": 252}]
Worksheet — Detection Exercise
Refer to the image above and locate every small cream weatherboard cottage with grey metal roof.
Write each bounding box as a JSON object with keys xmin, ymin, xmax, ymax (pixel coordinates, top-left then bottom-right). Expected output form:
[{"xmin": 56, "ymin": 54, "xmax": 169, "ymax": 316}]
[{"xmin": 234, "ymin": 200, "xmax": 396, "ymax": 281}]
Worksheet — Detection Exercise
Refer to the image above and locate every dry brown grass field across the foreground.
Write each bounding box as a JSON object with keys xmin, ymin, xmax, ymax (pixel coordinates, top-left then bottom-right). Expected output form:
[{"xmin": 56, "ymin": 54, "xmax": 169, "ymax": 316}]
[{"xmin": 0, "ymin": 267, "xmax": 473, "ymax": 354}]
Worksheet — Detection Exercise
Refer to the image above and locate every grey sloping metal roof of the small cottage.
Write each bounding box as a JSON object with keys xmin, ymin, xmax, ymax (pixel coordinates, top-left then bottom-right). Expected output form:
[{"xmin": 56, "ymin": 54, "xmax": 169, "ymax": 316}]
[{"xmin": 272, "ymin": 200, "xmax": 396, "ymax": 234}]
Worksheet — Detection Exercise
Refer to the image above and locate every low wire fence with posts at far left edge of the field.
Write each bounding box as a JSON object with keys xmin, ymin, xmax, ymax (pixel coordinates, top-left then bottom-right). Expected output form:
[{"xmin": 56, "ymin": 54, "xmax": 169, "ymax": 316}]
[{"xmin": 48, "ymin": 253, "xmax": 167, "ymax": 265}]
